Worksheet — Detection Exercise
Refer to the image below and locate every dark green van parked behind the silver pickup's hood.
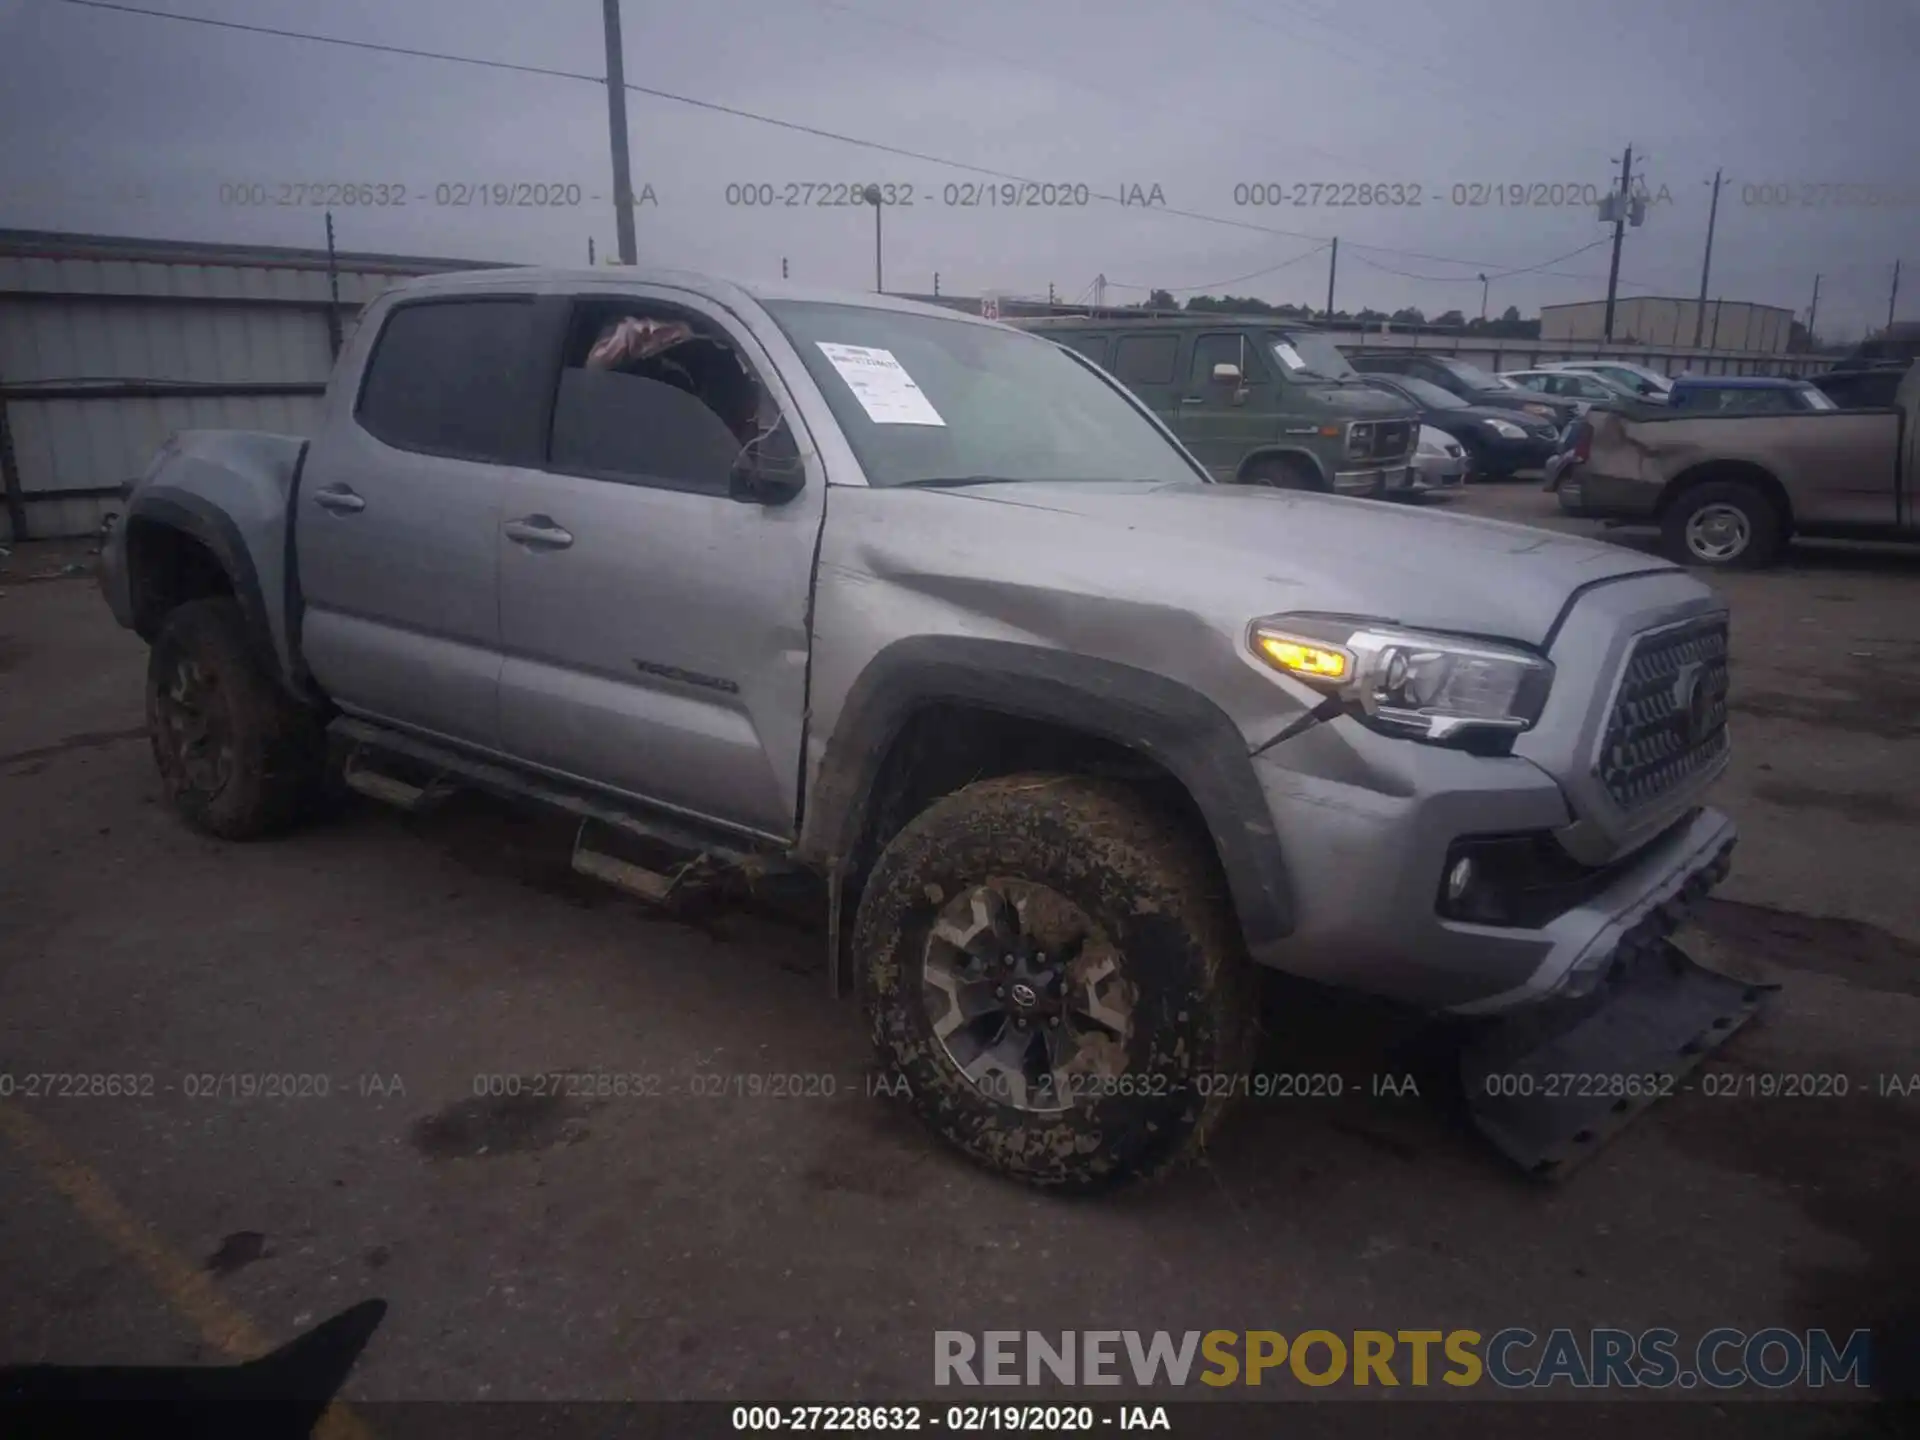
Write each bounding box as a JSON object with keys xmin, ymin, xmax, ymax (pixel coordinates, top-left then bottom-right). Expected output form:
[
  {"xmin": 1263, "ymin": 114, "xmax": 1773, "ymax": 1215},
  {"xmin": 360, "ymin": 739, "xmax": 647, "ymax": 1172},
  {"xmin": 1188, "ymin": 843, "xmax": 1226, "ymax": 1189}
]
[{"xmin": 1014, "ymin": 315, "xmax": 1419, "ymax": 495}]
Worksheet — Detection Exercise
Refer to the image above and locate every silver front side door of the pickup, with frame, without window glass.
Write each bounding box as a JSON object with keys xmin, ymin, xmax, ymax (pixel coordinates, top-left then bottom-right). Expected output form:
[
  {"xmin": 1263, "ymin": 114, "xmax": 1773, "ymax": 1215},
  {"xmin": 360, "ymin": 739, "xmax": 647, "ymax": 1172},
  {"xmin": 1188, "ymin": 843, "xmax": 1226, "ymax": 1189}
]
[{"xmin": 499, "ymin": 290, "xmax": 826, "ymax": 839}]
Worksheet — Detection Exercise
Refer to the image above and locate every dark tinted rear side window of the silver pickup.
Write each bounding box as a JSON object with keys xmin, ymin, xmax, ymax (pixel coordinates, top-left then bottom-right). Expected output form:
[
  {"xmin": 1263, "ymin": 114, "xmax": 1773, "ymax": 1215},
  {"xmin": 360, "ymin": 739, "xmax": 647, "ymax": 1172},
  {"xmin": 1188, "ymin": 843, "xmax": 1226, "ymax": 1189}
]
[{"xmin": 353, "ymin": 296, "xmax": 540, "ymax": 465}]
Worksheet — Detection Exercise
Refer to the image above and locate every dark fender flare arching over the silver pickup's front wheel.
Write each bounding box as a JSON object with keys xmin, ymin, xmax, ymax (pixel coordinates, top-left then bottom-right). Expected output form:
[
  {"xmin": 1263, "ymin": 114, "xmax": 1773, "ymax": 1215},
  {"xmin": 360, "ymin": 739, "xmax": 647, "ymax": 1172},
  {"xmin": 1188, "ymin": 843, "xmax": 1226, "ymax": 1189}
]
[{"xmin": 799, "ymin": 636, "xmax": 1294, "ymax": 947}]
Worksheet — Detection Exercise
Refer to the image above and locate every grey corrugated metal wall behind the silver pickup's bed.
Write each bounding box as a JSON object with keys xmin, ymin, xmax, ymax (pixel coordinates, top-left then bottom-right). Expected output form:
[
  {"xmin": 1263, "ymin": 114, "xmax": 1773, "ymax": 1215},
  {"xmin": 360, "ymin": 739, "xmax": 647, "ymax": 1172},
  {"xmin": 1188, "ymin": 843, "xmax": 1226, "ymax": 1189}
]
[{"xmin": 0, "ymin": 230, "xmax": 506, "ymax": 540}]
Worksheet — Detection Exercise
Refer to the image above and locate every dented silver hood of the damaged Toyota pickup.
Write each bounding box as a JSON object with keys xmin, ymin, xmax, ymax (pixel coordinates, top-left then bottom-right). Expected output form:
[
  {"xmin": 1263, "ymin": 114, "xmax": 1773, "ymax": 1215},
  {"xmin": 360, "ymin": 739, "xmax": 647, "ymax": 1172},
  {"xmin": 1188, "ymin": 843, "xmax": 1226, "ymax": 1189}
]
[{"xmin": 900, "ymin": 482, "xmax": 1678, "ymax": 647}]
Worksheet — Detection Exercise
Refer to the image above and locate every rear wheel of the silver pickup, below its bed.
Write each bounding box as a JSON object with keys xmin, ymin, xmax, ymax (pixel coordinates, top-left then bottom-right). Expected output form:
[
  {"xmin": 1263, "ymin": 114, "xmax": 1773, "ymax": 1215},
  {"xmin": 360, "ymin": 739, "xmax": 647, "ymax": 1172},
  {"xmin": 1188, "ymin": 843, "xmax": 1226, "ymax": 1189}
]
[{"xmin": 146, "ymin": 597, "xmax": 326, "ymax": 839}]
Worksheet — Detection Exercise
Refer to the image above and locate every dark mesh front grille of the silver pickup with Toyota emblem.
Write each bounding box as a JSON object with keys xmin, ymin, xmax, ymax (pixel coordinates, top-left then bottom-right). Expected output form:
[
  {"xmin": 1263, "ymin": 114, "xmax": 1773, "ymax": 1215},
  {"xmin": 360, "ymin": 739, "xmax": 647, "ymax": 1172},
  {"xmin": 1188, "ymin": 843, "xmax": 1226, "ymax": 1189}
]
[{"xmin": 1597, "ymin": 616, "xmax": 1726, "ymax": 810}]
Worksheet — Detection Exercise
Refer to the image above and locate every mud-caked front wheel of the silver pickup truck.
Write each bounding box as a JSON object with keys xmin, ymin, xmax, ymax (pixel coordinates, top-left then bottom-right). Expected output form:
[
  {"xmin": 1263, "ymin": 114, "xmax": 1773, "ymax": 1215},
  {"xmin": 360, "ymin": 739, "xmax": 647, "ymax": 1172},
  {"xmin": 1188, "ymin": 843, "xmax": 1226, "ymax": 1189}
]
[{"xmin": 854, "ymin": 776, "xmax": 1256, "ymax": 1190}]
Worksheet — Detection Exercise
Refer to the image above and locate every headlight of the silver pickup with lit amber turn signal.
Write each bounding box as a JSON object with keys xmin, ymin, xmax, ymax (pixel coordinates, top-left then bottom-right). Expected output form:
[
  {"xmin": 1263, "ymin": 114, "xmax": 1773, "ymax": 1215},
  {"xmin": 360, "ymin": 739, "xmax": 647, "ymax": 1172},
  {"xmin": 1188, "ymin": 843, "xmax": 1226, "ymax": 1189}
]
[{"xmin": 1248, "ymin": 614, "xmax": 1553, "ymax": 741}]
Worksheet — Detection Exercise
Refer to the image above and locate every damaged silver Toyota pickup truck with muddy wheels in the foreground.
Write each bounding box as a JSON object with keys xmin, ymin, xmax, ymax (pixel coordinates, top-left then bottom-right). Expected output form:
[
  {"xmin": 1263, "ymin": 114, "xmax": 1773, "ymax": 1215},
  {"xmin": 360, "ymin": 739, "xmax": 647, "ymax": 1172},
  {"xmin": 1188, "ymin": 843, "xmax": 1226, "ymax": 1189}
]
[{"xmin": 102, "ymin": 269, "xmax": 1758, "ymax": 1188}]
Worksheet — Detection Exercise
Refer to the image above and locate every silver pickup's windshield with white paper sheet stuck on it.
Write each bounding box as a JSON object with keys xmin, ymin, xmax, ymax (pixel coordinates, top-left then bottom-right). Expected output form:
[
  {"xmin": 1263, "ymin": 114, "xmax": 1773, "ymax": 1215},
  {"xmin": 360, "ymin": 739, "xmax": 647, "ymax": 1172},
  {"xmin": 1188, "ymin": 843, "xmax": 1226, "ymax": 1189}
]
[{"xmin": 766, "ymin": 300, "xmax": 1206, "ymax": 486}]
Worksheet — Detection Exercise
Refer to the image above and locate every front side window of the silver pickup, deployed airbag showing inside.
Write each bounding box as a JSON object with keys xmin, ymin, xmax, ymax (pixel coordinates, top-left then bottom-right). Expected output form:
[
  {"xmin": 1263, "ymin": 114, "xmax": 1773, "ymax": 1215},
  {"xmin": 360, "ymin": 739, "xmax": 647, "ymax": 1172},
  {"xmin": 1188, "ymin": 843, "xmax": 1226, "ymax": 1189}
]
[{"xmin": 547, "ymin": 301, "xmax": 780, "ymax": 495}]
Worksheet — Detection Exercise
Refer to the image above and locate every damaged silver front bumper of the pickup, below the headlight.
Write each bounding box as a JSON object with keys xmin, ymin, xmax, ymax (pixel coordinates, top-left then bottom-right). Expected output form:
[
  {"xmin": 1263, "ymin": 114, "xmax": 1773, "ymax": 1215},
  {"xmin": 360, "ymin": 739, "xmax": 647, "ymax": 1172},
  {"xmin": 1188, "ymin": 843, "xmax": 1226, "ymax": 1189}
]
[{"xmin": 1254, "ymin": 718, "xmax": 1736, "ymax": 1014}]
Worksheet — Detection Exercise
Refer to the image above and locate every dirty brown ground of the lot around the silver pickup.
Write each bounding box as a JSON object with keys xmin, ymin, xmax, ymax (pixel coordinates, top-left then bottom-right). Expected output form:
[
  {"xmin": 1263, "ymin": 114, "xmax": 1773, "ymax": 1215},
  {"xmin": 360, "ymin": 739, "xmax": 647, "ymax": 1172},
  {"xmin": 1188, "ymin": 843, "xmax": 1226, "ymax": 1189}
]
[{"xmin": 0, "ymin": 503, "xmax": 1920, "ymax": 1428}]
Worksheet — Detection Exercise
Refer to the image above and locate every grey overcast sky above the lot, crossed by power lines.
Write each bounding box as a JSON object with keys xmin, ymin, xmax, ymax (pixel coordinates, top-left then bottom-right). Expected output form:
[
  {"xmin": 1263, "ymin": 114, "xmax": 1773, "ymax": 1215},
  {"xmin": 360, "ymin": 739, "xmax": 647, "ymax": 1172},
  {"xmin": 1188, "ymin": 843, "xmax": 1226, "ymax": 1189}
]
[{"xmin": 0, "ymin": 0, "xmax": 1920, "ymax": 338}]
